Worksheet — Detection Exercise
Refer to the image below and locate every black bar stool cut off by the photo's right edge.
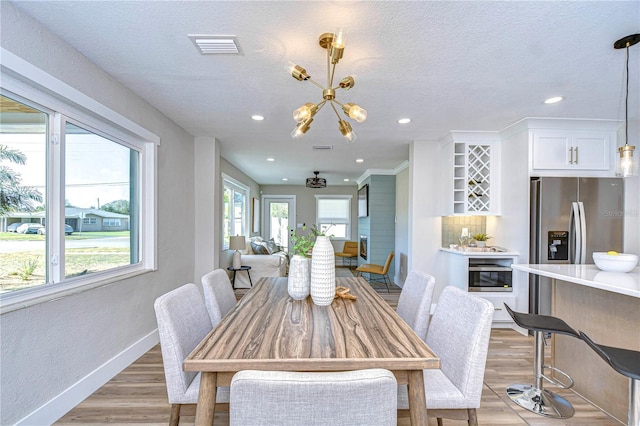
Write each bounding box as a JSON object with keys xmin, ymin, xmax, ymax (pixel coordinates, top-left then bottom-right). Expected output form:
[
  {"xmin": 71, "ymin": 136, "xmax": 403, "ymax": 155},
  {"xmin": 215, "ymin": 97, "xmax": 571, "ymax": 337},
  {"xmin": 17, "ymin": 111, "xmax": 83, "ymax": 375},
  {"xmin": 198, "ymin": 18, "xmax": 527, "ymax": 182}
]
[{"xmin": 580, "ymin": 331, "xmax": 640, "ymax": 426}]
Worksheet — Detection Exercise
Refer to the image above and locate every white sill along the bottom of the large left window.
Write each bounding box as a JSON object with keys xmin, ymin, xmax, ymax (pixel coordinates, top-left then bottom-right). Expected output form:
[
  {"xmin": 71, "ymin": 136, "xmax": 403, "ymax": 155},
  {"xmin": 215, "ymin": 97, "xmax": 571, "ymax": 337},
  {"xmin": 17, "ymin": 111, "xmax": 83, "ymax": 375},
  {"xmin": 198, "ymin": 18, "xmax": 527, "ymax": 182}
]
[{"xmin": 0, "ymin": 265, "xmax": 153, "ymax": 315}]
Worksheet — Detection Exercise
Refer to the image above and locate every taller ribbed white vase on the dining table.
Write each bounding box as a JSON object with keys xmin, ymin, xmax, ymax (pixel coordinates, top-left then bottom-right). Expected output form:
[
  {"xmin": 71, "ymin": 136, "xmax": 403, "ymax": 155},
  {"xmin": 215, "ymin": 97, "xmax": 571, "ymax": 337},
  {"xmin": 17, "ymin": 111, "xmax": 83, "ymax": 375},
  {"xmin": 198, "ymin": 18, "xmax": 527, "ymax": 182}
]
[{"xmin": 311, "ymin": 236, "xmax": 336, "ymax": 306}]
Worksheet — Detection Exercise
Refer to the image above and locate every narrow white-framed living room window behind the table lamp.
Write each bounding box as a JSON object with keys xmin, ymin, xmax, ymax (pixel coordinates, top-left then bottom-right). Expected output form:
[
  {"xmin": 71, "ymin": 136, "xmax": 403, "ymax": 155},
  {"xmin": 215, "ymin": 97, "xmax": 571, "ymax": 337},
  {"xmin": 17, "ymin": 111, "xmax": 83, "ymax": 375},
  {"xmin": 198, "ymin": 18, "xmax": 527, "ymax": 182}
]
[{"xmin": 222, "ymin": 175, "xmax": 249, "ymax": 249}]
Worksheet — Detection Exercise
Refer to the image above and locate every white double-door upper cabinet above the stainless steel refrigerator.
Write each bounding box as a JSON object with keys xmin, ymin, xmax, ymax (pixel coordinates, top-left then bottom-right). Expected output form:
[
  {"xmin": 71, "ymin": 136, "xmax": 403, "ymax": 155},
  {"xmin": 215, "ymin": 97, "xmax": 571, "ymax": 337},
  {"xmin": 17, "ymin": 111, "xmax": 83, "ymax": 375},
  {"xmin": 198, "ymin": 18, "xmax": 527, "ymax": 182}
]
[{"xmin": 531, "ymin": 130, "xmax": 613, "ymax": 171}]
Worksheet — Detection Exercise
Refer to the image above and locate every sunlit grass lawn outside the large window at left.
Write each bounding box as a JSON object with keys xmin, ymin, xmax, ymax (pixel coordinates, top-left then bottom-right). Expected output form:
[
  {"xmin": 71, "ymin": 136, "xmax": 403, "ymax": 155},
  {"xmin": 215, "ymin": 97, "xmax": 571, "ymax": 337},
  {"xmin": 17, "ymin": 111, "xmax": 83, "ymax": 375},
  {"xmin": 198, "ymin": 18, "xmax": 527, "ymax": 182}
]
[{"xmin": 0, "ymin": 231, "xmax": 130, "ymax": 292}]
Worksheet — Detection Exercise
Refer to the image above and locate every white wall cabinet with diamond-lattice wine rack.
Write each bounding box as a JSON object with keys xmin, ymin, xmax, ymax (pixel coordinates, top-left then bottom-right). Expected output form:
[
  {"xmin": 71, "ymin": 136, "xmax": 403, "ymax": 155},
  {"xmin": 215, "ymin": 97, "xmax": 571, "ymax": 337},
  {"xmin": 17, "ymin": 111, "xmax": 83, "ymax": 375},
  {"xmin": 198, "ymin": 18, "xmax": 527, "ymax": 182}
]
[{"xmin": 443, "ymin": 132, "xmax": 500, "ymax": 215}]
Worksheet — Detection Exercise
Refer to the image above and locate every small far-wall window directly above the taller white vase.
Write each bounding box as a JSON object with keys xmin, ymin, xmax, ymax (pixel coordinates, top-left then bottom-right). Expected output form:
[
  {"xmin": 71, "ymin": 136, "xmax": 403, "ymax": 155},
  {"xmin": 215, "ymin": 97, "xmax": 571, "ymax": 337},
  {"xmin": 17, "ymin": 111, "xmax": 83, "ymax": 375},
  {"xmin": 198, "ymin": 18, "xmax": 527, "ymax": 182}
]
[{"xmin": 316, "ymin": 195, "xmax": 351, "ymax": 240}]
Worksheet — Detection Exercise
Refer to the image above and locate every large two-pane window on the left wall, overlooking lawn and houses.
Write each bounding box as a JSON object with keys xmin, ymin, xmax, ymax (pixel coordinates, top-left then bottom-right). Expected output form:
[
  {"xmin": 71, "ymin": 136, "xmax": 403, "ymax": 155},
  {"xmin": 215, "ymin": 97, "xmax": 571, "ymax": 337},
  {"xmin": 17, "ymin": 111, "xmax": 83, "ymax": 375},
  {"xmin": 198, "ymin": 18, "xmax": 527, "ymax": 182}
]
[{"xmin": 0, "ymin": 61, "xmax": 158, "ymax": 306}]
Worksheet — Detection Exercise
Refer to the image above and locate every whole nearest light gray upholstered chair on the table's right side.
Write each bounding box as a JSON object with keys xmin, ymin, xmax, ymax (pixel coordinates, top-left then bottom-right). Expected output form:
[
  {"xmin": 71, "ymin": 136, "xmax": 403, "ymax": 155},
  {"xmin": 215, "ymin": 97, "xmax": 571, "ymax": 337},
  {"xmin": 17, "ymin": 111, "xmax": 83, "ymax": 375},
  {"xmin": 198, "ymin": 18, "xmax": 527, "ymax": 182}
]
[{"xmin": 398, "ymin": 286, "xmax": 493, "ymax": 425}]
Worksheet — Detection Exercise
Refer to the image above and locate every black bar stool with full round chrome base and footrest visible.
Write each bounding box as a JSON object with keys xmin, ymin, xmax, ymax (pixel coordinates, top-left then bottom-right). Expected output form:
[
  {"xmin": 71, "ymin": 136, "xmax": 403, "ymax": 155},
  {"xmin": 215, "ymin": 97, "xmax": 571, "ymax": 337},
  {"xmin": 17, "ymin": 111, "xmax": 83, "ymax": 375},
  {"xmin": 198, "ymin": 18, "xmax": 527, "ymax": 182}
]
[{"xmin": 504, "ymin": 303, "xmax": 580, "ymax": 419}]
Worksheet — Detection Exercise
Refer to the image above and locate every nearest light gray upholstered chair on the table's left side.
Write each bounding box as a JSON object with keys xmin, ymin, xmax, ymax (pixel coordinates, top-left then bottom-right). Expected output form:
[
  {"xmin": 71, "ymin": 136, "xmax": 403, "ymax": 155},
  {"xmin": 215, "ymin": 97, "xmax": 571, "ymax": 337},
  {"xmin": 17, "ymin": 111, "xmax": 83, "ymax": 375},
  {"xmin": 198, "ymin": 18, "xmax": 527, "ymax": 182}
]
[{"xmin": 153, "ymin": 284, "xmax": 229, "ymax": 426}]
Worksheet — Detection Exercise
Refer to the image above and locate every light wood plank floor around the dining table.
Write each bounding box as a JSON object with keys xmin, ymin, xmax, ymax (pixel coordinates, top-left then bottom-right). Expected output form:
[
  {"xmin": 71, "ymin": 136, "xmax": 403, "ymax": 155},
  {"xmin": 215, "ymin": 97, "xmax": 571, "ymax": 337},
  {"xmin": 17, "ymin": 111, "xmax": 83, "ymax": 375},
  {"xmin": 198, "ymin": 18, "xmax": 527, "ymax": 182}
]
[{"xmin": 56, "ymin": 272, "xmax": 621, "ymax": 426}]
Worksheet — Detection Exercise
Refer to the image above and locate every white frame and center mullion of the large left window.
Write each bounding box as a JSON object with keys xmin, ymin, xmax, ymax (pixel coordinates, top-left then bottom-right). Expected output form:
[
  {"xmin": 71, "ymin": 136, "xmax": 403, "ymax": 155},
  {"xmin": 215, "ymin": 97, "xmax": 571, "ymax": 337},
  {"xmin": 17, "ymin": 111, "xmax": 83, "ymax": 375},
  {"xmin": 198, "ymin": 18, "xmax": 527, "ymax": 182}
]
[{"xmin": 0, "ymin": 48, "xmax": 160, "ymax": 313}]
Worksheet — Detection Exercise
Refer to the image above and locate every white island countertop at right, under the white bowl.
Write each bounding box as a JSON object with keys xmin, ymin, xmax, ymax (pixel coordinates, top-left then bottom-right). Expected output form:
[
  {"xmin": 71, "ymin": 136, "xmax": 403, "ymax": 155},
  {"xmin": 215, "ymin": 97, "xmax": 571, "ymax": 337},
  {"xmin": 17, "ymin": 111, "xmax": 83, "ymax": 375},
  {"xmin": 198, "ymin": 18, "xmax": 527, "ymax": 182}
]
[{"xmin": 511, "ymin": 264, "xmax": 640, "ymax": 298}]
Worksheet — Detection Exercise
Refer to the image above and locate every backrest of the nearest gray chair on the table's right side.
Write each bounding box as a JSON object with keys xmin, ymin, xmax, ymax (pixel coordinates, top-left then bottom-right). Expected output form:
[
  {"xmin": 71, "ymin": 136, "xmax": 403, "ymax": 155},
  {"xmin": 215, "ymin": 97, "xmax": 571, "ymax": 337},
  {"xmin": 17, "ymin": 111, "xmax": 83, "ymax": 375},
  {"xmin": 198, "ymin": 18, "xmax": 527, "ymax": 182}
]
[{"xmin": 426, "ymin": 286, "xmax": 493, "ymax": 408}]
